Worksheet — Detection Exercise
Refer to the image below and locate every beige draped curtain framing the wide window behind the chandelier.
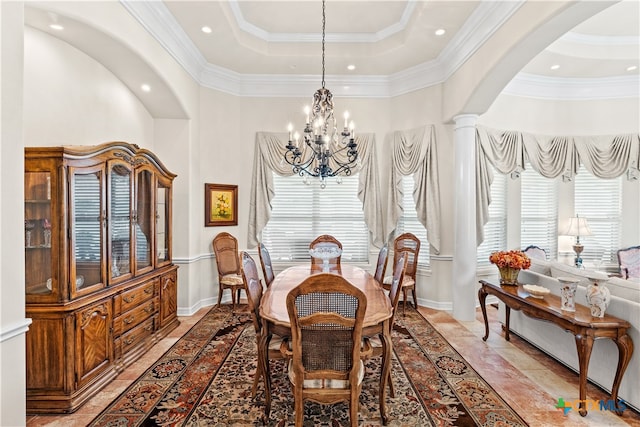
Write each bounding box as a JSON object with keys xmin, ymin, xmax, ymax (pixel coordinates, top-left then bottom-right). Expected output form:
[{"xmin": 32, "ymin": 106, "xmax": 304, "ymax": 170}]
[{"xmin": 249, "ymin": 132, "xmax": 383, "ymax": 247}]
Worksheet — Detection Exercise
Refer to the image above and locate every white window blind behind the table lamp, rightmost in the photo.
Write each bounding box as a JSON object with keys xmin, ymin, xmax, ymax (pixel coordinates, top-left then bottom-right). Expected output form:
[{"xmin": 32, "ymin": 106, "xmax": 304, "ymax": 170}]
[{"xmin": 574, "ymin": 166, "xmax": 623, "ymax": 266}]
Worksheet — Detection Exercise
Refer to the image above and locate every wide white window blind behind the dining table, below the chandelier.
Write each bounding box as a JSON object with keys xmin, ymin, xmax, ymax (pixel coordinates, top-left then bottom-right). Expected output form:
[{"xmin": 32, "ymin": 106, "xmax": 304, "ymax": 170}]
[{"xmin": 262, "ymin": 174, "xmax": 369, "ymax": 262}]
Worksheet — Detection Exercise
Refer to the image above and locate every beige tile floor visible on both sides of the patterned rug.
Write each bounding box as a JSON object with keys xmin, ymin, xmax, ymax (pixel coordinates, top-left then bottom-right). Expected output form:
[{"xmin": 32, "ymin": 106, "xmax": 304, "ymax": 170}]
[{"xmin": 27, "ymin": 307, "xmax": 640, "ymax": 427}]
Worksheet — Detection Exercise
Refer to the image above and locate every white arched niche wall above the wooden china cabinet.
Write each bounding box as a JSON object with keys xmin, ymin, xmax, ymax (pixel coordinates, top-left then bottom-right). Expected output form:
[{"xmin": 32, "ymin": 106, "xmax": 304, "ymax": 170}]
[{"xmin": 24, "ymin": 27, "xmax": 154, "ymax": 150}]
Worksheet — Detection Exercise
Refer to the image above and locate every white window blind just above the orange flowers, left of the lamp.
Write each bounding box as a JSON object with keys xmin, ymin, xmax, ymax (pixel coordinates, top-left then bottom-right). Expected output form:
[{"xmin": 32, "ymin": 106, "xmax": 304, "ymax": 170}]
[{"xmin": 520, "ymin": 167, "xmax": 558, "ymax": 259}]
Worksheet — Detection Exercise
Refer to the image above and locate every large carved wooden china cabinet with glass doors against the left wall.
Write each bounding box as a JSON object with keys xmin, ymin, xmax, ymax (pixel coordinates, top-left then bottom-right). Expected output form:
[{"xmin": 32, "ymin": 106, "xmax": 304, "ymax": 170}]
[{"xmin": 24, "ymin": 142, "xmax": 179, "ymax": 413}]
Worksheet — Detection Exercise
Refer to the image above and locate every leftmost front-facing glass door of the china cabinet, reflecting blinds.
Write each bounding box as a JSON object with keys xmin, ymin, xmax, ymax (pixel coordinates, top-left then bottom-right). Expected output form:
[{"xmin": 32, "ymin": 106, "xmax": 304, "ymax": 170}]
[{"xmin": 70, "ymin": 167, "xmax": 106, "ymax": 296}]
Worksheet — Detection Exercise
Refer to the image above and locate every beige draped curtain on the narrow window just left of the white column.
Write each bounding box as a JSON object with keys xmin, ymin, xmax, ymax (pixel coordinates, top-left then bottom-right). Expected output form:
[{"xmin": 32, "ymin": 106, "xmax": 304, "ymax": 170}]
[{"xmin": 386, "ymin": 125, "xmax": 440, "ymax": 254}]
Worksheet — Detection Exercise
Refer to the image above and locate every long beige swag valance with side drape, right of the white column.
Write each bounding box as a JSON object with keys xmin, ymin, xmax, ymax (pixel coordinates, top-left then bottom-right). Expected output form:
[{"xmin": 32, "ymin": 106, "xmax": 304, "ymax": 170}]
[{"xmin": 476, "ymin": 126, "xmax": 640, "ymax": 245}]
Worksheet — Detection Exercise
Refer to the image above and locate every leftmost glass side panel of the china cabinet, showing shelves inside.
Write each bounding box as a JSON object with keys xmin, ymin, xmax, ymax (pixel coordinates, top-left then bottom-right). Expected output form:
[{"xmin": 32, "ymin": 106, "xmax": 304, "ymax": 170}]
[{"xmin": 24, "ymin": 172, "xmax": 54, "ymax": 295}]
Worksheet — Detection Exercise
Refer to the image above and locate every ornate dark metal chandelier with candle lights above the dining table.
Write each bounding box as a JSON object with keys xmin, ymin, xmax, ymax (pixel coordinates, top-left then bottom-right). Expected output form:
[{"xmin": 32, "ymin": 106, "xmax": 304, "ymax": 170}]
[{"xmin": 284, "ymin": 0, "xmax": 358, "ymax": 188}]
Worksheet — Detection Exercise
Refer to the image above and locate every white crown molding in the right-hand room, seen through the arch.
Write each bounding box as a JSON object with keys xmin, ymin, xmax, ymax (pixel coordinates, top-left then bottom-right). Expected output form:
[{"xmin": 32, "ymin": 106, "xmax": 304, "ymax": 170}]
[{"xmin": 502, "ymin": 73, "xmax": 640, "ymax": 101}]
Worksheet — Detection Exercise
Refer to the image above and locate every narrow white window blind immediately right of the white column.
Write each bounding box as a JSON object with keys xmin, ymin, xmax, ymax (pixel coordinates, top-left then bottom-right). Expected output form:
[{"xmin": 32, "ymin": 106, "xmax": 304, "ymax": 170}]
[{"xmin": 478, "ymin": 170, "xmax": 508, "ymax": 266}]
